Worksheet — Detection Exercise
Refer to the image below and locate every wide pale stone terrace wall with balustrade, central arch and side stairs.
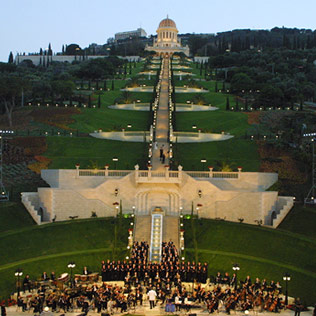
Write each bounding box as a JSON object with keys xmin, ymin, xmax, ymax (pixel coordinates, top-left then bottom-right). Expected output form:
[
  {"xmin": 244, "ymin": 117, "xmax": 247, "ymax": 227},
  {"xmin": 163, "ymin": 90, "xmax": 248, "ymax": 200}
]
[{"xmin": 22, "ymin": 166, "xmax": 293, "ymax": 227}]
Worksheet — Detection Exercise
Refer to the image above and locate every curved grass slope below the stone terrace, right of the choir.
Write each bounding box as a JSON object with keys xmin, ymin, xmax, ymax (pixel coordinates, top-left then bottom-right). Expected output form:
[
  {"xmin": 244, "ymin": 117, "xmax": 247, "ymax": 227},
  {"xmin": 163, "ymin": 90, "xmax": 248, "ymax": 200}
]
[{"xmin": 184, "ymin": 219, "xmax": 316, "ymax": 304}]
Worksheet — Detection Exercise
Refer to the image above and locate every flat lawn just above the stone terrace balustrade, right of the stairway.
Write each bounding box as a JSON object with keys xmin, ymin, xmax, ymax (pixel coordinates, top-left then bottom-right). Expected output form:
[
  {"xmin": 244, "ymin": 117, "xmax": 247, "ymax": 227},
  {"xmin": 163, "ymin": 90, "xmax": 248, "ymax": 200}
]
[{"xmin": 174, "ymin": 139, "xmax": 260, "ymax": 172}]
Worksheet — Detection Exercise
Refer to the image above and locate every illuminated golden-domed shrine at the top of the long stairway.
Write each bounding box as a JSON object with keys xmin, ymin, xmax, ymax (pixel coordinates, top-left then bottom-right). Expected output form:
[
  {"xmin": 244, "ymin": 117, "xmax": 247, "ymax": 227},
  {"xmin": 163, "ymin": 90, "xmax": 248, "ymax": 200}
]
[{"xmin": 145, "ymin": 16, "xmax": 190, "ymax": 56}]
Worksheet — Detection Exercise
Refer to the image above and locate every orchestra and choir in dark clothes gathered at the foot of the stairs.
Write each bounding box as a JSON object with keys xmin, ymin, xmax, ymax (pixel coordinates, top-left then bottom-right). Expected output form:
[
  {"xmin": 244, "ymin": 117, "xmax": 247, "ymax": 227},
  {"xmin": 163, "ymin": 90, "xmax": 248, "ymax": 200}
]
[{"xmin": 13, "ymin": 241, "xmax": 296, "ymax": 314}]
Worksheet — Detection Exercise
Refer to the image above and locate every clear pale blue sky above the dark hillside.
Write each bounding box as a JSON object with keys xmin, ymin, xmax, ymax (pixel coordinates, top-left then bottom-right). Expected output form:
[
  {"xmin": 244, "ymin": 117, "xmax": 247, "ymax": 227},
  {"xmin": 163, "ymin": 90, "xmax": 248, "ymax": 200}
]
[{"xmin": 0, "ymin": 0, "xmax": 316, "ymax": 62}]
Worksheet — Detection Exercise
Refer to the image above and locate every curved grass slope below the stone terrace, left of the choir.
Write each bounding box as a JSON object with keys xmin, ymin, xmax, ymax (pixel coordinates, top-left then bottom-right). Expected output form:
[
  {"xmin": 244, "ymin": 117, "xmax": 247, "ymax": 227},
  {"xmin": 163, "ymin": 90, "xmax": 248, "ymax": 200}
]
[{"xmin": 0, "ymin": 218, "xmax": 130, "ymax": 297}]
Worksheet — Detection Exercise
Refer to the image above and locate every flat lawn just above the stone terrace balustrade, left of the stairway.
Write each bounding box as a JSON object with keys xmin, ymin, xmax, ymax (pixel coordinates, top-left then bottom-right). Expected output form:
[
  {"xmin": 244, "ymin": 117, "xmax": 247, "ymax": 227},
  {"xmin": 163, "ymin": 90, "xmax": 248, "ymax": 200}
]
[{"xmin": 45, "ymin": 137, "xmax": 147, "ymax": 170}]
